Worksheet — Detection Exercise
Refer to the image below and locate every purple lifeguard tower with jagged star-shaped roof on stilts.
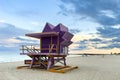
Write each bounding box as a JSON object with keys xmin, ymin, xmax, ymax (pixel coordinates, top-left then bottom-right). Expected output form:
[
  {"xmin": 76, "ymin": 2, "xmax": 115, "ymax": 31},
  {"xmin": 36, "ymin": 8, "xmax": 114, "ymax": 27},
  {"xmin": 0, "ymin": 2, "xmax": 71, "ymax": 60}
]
[{"xmin": 20, "ymin": 23, "xmax": 73, "ymax": 69}]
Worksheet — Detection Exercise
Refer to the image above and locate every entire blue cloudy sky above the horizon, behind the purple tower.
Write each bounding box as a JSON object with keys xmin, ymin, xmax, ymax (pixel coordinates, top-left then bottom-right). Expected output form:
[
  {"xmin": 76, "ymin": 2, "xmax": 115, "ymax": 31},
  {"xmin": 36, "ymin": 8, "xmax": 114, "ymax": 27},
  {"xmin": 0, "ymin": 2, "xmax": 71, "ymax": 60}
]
[{"xmin": 0, "ymin": 0, "xmax": 120, "ymax": 54}]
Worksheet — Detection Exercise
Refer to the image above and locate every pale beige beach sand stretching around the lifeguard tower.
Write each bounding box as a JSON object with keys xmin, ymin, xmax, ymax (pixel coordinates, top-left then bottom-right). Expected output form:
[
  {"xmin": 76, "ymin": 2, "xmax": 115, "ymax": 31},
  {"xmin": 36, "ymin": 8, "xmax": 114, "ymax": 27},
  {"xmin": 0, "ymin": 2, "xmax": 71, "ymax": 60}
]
[{"xmin": 0, "ymin": 55, "xmax": 120, "ymax": 80}]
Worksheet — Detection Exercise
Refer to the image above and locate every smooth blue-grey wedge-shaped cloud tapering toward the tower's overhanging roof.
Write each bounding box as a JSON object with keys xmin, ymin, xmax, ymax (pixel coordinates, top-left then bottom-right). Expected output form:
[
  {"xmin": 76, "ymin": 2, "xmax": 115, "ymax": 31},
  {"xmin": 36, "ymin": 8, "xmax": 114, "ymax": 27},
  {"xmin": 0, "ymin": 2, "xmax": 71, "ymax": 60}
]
[{"xmin": 0, "ymin": 22, "xmax": 30, "ymax": 39}]
